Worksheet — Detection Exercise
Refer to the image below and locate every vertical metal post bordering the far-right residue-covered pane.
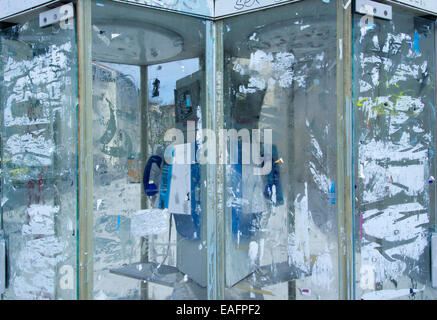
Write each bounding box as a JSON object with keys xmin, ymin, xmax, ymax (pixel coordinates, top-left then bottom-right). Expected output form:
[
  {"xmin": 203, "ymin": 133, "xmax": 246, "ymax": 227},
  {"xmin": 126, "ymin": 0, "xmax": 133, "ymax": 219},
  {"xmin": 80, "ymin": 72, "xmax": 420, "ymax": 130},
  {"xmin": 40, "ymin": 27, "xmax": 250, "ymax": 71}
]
[{"xmin": 337, "ymin": 0, "xmax": 354, "ymax": 300}]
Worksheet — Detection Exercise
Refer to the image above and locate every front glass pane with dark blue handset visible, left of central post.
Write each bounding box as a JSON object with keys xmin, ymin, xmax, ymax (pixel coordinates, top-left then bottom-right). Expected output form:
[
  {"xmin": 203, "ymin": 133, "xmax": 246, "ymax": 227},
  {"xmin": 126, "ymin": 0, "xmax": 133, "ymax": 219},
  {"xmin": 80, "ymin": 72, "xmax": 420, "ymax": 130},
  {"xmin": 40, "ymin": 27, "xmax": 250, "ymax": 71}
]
[{"xmin": 92, "ymin": 1, "xmax": 206, "ymax": 299}]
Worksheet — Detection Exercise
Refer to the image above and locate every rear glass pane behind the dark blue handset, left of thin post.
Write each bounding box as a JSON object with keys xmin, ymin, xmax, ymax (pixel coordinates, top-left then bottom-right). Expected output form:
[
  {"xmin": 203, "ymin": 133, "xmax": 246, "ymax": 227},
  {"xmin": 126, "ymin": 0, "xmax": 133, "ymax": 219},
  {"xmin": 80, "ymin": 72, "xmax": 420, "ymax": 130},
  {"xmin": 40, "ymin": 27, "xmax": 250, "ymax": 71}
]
[{"xmin": 93, "ymin": 62, "xmax": 141, "ymax": 299}]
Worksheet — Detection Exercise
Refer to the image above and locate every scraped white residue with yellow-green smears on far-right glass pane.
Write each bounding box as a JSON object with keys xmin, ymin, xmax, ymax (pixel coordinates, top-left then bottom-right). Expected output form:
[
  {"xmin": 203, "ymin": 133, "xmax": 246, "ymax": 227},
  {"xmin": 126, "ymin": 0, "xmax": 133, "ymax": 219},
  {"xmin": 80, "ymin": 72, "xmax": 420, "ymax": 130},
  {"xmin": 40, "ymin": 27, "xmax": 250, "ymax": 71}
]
[{"xmin": 357, "ymin": 23, "xmax": 434, "ymax": 299}]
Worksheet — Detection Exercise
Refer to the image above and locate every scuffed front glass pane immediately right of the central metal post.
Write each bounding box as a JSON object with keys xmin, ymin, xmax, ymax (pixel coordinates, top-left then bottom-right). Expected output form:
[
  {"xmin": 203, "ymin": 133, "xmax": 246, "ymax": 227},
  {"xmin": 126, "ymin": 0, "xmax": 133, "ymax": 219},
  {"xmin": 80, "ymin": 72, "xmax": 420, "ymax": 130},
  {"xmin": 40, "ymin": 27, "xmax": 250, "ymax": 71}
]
[{"xmin": 224, "ymin": 0, "xmax": 342, "ymax": 299}]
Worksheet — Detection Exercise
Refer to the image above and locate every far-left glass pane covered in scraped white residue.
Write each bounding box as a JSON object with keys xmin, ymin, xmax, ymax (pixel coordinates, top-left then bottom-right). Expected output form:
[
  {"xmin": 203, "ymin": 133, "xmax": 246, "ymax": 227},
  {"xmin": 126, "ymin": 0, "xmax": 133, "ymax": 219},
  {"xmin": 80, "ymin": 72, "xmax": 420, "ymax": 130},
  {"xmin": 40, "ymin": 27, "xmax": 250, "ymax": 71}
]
[{"xmin": 0, "ymin": 18, "xmax": 78, "ymax": 299}]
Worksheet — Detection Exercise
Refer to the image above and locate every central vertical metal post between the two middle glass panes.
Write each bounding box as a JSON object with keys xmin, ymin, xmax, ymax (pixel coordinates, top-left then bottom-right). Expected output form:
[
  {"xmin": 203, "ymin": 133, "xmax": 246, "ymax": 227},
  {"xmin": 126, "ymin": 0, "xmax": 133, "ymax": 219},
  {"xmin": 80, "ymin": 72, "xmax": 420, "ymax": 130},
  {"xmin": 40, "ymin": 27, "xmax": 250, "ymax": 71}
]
[{"xmin": 205, "ymin": 21, "xmax": 225, "ymax": 300}]
